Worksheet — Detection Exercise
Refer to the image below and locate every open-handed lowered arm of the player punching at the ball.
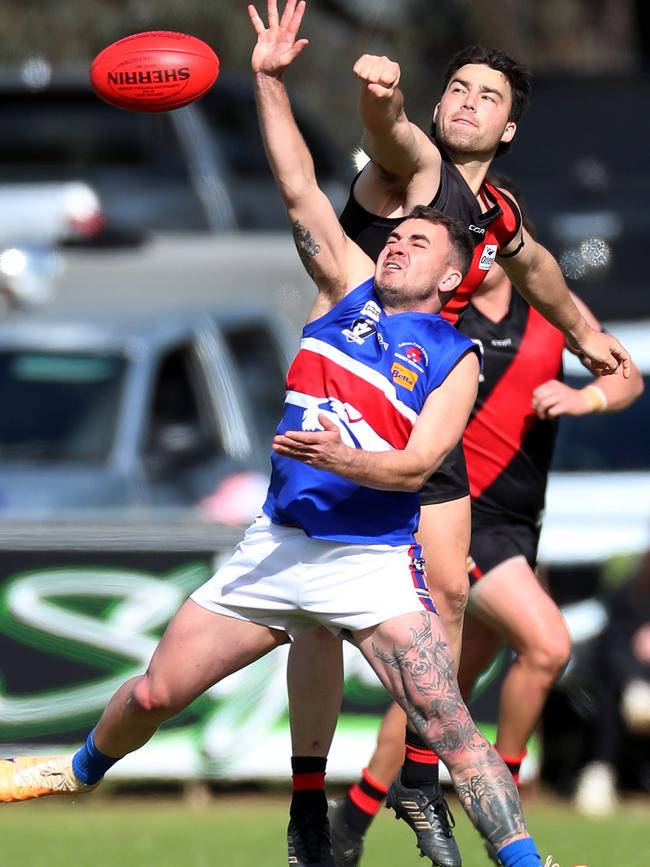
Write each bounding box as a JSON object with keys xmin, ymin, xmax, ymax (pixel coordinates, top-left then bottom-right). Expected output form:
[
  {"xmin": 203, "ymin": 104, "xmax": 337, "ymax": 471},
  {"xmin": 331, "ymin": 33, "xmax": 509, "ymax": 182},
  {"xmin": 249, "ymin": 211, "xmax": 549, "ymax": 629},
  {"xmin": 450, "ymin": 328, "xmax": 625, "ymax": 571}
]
[{"xmin": 499, "ymin": 213, "xmax": 631, "ymax": 379}]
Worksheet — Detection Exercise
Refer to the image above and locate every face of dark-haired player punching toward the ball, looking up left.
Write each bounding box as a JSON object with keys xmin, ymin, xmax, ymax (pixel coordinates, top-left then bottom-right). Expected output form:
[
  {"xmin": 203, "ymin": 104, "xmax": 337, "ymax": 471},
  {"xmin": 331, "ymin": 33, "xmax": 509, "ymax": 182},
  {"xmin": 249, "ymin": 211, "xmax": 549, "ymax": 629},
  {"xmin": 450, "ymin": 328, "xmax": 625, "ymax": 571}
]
[{"xmin": 433, "ymin": 63, "xmax": 517, "ymax": 158}]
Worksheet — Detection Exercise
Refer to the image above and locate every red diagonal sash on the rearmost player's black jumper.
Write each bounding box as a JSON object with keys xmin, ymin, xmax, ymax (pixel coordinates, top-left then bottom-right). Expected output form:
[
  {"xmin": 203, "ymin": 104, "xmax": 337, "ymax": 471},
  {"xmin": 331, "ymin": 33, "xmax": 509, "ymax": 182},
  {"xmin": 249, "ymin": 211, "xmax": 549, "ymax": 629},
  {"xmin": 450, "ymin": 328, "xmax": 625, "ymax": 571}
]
[{"xmin": 463, "ymin": 307, "xmax": 564, "ymax": 498}]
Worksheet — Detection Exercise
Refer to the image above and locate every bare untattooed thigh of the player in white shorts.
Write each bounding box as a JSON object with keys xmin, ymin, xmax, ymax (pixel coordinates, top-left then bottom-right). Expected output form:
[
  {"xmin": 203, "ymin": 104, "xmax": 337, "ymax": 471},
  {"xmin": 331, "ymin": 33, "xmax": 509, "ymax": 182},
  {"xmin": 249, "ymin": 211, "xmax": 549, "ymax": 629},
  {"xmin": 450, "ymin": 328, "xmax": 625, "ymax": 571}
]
[{"xmin": 147, "ymin": 599, "xmax": 288, "ymax": 706}]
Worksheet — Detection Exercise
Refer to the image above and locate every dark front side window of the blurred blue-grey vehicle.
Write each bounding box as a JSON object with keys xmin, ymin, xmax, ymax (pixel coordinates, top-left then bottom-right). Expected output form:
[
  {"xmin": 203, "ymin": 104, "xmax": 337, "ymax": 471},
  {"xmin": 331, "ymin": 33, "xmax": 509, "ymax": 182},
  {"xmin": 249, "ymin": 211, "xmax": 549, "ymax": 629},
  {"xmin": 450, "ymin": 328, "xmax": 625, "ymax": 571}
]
[{"xmin": 145, "ymin": 347, "xmax": 220, "ymax": 462}]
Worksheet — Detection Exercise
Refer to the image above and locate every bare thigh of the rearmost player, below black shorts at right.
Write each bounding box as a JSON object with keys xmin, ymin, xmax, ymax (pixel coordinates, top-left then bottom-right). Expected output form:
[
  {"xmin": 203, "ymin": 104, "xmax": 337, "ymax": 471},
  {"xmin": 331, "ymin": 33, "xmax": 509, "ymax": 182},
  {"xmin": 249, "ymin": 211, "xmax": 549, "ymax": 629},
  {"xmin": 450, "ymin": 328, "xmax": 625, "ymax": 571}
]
[{"xmin": 470, "ymin": 556, "xmax": 567, "ymax": 653}]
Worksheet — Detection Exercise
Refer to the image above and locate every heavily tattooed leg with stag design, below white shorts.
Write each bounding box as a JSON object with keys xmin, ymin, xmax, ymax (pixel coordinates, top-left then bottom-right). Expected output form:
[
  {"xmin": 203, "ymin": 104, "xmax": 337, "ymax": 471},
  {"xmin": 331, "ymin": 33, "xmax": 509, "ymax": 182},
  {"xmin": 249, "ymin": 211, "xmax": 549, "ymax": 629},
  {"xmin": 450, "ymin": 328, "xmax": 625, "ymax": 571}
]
[{"xmin": 355, "ymin": 612, "xmax": 528, "ymax": 849}]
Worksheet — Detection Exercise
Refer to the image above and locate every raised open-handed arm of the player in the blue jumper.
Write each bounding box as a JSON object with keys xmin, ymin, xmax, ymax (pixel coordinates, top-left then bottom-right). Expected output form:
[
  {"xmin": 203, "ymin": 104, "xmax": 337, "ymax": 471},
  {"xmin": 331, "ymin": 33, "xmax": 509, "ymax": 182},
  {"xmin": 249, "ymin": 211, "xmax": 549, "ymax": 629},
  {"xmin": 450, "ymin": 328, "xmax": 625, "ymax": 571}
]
[{"xmin": 248, "ymin": 0, "xmax": 374, "ymax": 315}]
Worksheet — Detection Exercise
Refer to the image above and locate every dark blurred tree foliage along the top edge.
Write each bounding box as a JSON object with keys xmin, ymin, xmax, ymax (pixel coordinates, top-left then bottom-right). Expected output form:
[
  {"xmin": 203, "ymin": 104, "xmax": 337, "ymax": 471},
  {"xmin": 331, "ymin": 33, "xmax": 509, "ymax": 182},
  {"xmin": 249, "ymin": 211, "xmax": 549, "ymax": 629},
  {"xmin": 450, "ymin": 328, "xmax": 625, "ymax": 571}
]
[{"xmin": 0, "ymin": 0, "xmax": 636, "ymax": 145}]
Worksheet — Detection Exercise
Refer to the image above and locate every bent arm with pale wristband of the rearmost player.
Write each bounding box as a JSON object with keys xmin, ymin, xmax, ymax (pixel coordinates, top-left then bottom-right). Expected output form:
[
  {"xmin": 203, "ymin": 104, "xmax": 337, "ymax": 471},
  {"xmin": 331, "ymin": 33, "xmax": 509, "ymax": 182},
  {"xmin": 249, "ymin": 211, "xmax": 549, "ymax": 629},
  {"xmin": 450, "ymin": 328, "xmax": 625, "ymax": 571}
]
[{"xmin": 533, "ymin": 293, "xmax": 643, "ymax": 418}]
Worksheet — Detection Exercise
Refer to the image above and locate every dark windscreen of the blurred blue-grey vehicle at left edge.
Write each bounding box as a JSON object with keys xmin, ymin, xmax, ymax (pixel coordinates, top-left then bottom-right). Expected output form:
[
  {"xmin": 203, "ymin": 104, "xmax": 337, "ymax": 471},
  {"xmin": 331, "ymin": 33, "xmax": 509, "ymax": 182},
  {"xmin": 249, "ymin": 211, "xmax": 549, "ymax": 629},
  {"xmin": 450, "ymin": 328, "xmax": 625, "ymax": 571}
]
[{"xmin": 0, "ymin": 351, "xmax": 125, "ymax": 463}]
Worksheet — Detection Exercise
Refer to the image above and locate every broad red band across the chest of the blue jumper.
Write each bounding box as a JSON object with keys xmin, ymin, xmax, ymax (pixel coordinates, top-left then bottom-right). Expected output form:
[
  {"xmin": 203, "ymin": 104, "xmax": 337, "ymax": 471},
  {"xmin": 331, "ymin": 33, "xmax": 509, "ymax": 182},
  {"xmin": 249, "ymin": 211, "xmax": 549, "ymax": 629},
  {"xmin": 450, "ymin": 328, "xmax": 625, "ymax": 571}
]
[{"xmin": 287, "ymin": 349, "xmax": 413, "ymax": 449}]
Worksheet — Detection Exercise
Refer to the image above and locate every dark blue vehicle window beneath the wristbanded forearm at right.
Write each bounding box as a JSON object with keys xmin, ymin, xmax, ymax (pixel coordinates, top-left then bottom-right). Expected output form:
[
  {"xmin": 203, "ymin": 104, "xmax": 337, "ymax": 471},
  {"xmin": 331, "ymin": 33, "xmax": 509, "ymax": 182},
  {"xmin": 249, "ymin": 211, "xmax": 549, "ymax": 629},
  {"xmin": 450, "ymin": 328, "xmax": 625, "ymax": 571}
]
[{"xmin": 553, "ymin": 377, "xmax": 650, "ymax": 473}]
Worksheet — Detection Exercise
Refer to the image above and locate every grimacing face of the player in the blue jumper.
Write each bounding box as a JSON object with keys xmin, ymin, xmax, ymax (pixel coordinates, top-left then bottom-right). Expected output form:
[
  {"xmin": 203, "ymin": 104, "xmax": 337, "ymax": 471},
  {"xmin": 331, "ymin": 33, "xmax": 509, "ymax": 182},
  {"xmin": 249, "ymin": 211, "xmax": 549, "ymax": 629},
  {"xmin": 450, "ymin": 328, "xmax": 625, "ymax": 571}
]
[{"xmin": 375, "ymin": 219, "xmax": 461, "ymax": 313}]
